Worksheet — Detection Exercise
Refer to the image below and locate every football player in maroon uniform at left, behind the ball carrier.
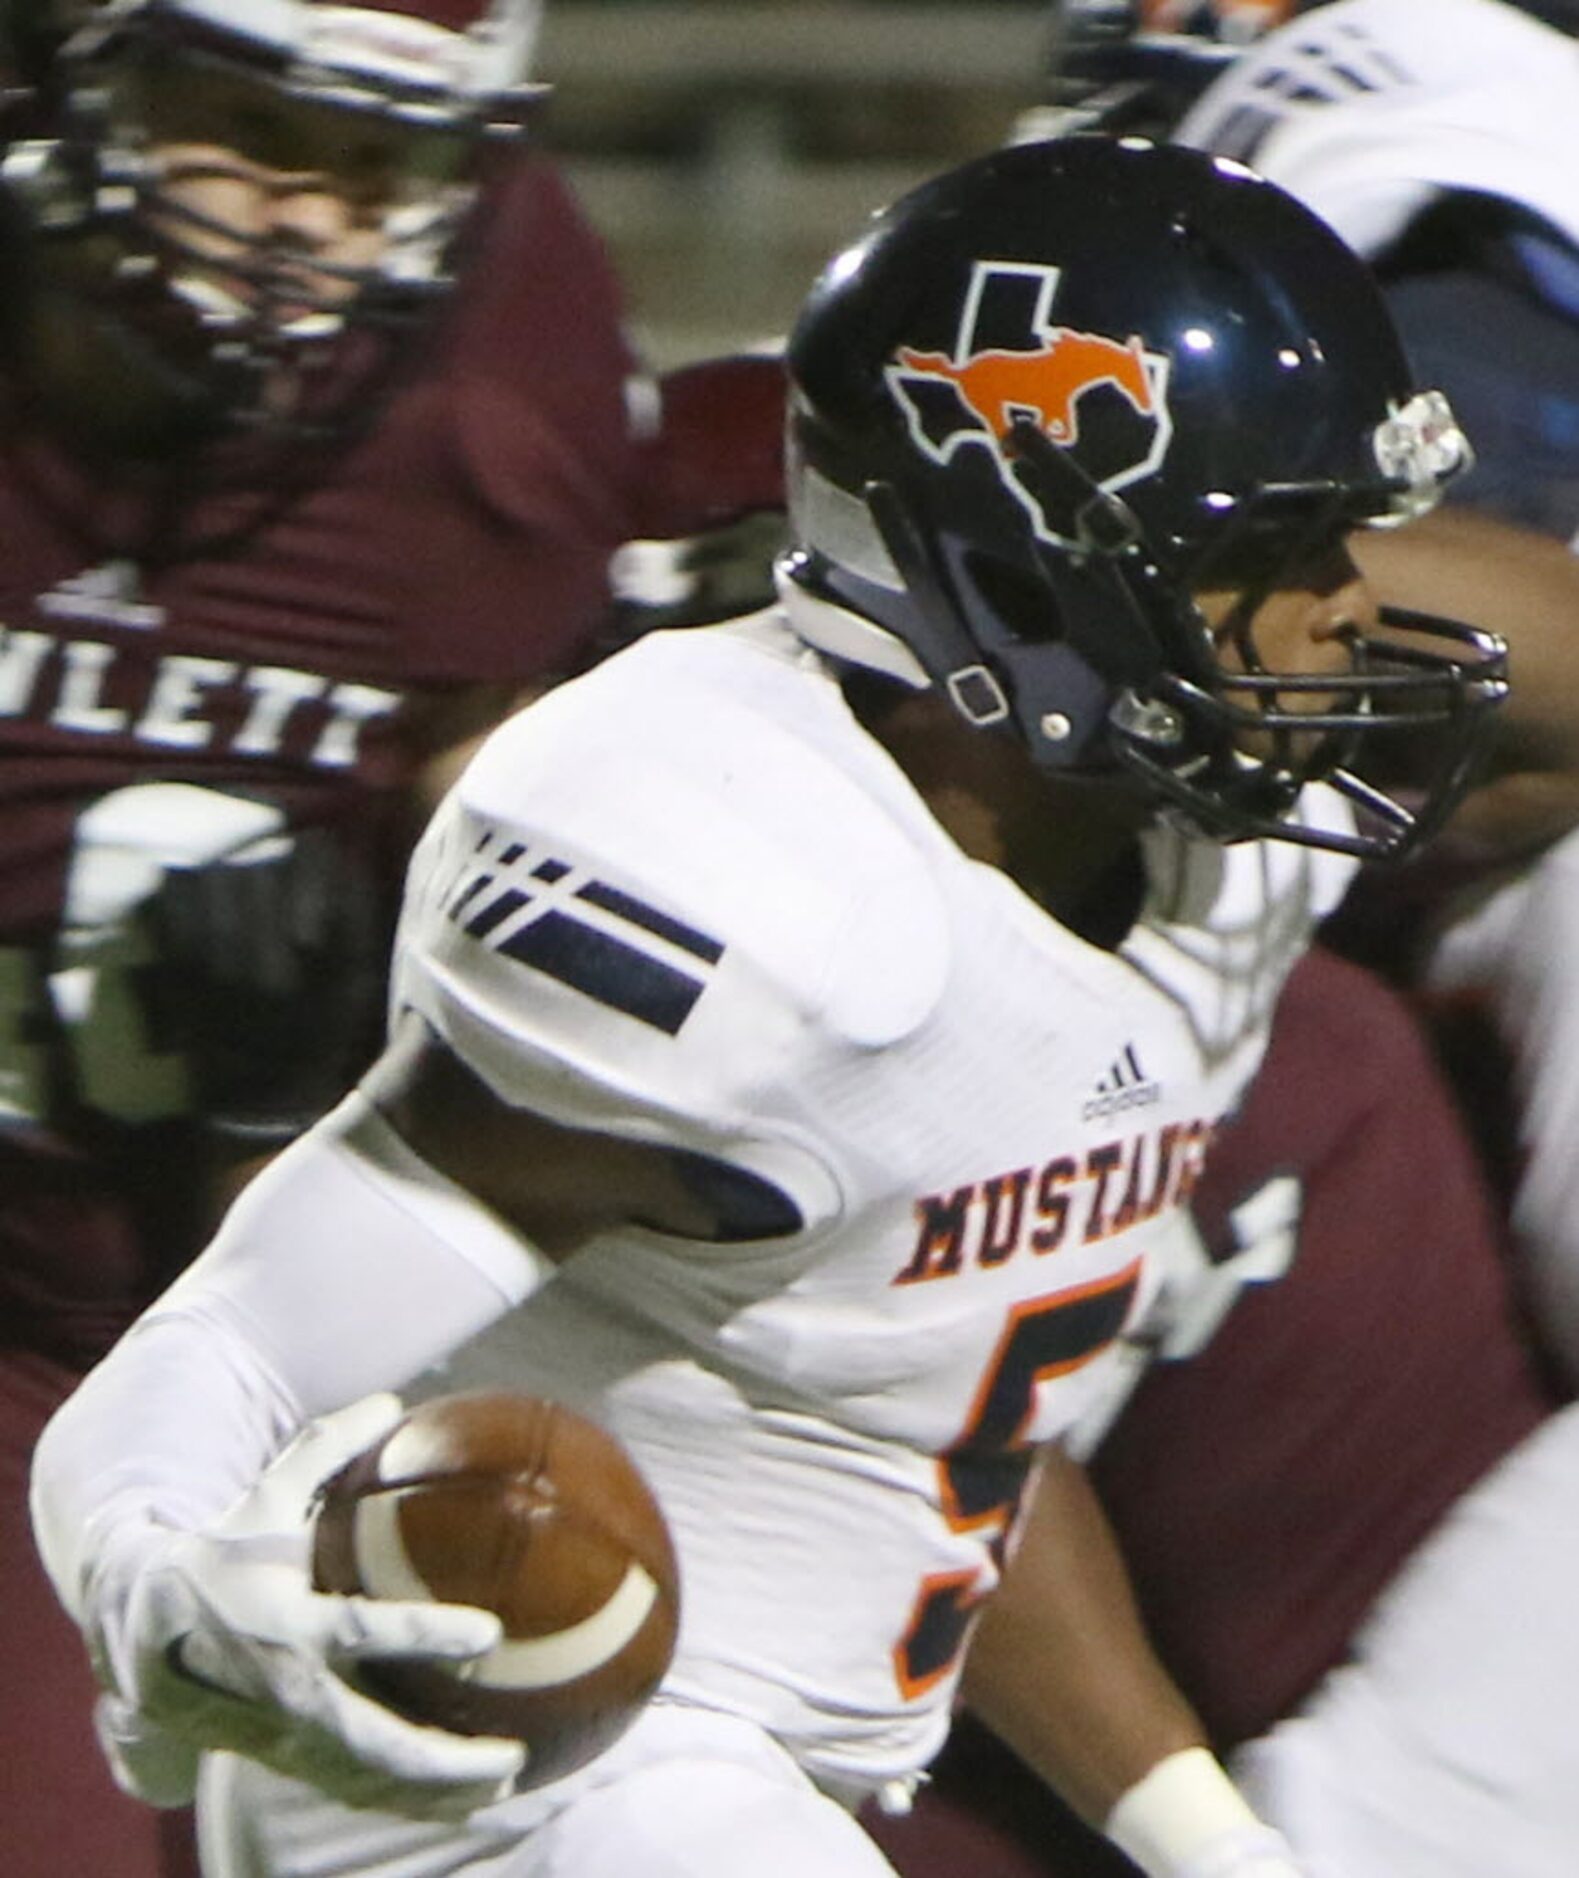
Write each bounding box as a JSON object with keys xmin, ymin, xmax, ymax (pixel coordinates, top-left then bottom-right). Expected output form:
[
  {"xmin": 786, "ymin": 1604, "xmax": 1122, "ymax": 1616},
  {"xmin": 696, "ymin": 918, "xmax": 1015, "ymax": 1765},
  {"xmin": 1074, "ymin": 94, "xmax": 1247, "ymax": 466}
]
[{"xmin": 0, "ymin": 0, "xmax": 636, "ymax": 1878}]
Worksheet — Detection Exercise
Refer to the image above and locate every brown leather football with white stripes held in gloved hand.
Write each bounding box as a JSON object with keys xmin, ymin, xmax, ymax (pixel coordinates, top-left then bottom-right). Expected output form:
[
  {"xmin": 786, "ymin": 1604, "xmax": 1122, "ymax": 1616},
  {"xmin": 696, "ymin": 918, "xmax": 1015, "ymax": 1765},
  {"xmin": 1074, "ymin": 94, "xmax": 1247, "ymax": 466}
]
[{"xmin": 314, "ymin": 1392, "xmax": 680, "ymax": 1786}]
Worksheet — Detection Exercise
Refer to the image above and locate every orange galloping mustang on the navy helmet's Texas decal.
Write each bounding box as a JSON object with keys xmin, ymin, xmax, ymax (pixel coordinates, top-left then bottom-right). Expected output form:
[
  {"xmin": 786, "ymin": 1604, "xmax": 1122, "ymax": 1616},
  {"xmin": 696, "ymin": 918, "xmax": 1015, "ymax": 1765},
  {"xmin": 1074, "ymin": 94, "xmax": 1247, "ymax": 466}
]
[{"xmin": 897, "ymin": 327, "xmax": 1158, "ymax": 447}]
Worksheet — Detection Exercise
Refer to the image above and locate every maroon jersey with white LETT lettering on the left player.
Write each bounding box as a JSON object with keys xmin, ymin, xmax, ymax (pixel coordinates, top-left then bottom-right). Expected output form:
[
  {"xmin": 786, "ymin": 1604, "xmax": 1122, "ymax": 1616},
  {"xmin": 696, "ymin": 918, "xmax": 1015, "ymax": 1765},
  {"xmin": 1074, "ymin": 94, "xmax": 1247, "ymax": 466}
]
[{"xmin": 0, "ymin": 146, "xmax": 640, "ymax": 1343}]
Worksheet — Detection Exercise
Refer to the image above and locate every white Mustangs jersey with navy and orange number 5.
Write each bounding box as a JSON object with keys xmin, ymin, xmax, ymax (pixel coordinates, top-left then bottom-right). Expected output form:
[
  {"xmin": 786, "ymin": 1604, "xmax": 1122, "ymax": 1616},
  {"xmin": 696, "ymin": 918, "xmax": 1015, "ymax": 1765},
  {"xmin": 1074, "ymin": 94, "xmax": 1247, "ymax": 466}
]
[{"xmin": 394, "ymin": 612, "xmax": 1352, "ymax": 1782}]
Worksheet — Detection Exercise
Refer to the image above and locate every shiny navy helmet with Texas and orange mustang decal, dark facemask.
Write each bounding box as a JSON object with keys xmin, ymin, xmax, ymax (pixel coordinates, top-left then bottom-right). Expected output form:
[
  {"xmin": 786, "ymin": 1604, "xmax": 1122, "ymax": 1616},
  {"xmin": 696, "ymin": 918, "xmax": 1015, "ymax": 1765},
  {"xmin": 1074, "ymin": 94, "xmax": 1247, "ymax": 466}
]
[{"xmin": 783, "ymin": 137, "xmax": 1506, "ymax": 854}]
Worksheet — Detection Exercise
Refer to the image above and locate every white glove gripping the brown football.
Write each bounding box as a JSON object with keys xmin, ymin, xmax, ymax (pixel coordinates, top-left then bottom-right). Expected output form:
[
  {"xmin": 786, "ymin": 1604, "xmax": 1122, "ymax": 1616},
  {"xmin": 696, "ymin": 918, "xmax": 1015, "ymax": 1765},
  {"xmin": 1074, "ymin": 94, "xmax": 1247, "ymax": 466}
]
[{"xmin": 88, "ymin": 1395, "xmax": 526, "ymax": 1818}]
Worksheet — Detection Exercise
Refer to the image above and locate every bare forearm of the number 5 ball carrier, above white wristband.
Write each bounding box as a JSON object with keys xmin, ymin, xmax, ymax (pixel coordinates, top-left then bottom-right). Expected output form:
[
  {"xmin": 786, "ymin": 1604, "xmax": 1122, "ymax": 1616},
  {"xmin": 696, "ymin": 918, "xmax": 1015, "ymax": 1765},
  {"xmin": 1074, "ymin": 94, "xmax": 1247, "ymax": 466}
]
[{"xmin": 965, "ymin": 1454, "xmax": 1205, "ymax": 1827}]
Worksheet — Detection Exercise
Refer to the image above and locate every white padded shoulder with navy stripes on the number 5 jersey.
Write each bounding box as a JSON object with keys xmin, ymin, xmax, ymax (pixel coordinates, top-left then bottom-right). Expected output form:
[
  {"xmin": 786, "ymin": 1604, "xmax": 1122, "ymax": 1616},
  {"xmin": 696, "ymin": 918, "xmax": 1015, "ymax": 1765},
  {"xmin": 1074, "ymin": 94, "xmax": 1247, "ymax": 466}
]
[{"xmin": 402, "ymin": 614, "xmax": 948, "ymax": 1114}]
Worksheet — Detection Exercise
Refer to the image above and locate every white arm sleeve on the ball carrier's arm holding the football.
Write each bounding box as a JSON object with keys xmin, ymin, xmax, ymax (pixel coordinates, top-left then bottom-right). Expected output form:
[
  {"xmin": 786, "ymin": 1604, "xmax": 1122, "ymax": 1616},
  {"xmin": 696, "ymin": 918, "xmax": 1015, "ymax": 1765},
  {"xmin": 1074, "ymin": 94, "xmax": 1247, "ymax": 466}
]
[{"xmin": 32, "ymin": 1095, "xmax": 552, "ymax": 1619}]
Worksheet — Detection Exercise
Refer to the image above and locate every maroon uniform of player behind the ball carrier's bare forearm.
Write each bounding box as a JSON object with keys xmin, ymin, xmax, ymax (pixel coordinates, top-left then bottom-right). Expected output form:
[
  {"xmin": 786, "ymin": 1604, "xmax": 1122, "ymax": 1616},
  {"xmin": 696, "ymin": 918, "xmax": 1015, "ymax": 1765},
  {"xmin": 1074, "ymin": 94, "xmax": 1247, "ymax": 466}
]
[{"xmin": 875, "ymin": 950, "xmax": 1553, "ymax": 1878}]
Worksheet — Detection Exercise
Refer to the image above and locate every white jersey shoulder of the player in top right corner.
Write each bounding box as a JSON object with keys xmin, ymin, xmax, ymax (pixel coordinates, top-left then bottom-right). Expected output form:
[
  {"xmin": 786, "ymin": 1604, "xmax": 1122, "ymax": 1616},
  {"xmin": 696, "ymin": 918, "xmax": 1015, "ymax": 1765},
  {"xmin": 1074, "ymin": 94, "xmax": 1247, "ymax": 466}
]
[{"xmin": 1177, "ymin": 0, "xmax": 1579, "ymax": 255}]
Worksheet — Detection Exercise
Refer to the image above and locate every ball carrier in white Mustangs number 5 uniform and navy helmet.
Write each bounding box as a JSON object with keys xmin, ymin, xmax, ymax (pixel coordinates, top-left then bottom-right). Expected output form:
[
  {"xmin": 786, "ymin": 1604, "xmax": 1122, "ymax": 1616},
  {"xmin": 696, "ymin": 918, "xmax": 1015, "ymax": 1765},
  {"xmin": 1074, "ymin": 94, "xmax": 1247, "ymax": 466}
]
[{"xmin": 27, "ymin": 141, "xmax": 1504, "ymax": 1878}]
